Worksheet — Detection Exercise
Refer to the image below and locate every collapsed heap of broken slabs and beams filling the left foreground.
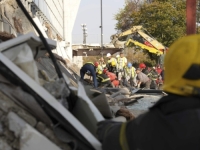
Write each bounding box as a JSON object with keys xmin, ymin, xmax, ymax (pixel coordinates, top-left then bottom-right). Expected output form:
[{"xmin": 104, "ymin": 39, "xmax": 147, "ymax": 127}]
[{"xmin": 0, "ymin": 1, "xmax": 163, "ymax": 150}]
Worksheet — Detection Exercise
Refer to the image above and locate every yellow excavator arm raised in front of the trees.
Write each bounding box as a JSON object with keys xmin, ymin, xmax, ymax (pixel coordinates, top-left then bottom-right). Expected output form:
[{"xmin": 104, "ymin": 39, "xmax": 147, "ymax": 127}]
[{"xmin": 111, "ymin": 26, "xmax": 167, "ymax": 63}]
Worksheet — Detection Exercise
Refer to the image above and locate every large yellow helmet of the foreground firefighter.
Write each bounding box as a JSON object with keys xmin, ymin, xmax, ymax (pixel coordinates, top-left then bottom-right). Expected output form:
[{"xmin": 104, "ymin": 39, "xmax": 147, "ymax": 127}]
[{"xmin": 163, "ymin": 35, "xmax": 200, "ymax": 96}]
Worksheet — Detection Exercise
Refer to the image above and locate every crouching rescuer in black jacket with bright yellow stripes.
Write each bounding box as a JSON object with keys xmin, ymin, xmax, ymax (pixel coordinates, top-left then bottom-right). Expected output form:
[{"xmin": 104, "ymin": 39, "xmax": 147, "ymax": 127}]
[{"xmin": 97, "ymin": 73, "xmax": 113, "ymax": 87}]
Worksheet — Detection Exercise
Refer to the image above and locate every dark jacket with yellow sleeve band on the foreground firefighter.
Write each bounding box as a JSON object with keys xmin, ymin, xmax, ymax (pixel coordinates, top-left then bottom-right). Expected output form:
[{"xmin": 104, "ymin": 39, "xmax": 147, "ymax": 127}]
[{"xmin": 98, "ymin": 94, "xmax": 200, "ymax": 150}]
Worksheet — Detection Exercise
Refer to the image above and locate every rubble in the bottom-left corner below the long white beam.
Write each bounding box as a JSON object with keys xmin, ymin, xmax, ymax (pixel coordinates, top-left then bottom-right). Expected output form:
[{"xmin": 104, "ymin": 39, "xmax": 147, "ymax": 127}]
[{"xmin": 0, "ymin": 85, "xmax": 70, "ymax": 150}]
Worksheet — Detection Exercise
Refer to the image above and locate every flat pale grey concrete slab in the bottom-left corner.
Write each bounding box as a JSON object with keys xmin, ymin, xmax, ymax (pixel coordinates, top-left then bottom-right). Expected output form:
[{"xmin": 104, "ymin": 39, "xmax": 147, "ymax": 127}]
[{"xmin": 7, "ymin": 112, "xmax": 61, "ymax": 150}]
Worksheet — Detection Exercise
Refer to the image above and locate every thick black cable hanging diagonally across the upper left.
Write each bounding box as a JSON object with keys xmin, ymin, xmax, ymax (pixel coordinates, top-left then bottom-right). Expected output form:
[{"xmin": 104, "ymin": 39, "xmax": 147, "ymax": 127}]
[{"xmin": 16, "ymin": 0, "xmax": 63, "ymax": 78}]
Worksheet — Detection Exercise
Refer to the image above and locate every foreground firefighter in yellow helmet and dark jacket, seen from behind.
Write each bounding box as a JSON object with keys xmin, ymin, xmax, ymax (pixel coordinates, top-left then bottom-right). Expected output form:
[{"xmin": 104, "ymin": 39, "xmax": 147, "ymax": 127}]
[{"xmin": 97, "ymin": 35, "xmax": 200, "ymax": 150}]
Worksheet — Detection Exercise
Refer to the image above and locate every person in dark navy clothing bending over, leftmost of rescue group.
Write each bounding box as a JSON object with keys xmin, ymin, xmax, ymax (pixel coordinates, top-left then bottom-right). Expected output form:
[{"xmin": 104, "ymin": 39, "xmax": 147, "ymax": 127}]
[{"xmin": 80, "ymin": 62, "xmax": 97, "ymax": 88}]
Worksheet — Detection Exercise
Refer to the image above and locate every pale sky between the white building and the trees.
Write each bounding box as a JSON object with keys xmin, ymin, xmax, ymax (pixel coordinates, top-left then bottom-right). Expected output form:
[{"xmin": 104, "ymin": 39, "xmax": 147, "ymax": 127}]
[{"xmin": 72, "ymin": 0, "xmax": 125, "ymax": 44}]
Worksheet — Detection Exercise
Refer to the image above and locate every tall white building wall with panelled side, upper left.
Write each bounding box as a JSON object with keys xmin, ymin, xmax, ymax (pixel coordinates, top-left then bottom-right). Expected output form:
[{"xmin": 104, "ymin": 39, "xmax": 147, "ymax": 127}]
[{"xmin": 33, "ymin": 0, "xmax": 80, "ymax": 60}]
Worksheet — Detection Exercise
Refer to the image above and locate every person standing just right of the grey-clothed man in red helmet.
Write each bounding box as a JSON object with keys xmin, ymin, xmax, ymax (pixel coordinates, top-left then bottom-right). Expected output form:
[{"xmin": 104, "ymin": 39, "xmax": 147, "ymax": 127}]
[{"xmin": 147, "ymin": 67, "xmax": 158, "ymax": 89}]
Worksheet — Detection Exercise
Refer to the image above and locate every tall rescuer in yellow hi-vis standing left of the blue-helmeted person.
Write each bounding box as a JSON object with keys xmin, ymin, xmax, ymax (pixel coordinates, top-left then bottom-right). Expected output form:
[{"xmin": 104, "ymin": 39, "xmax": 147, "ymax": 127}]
[{"xmin": 117, "ymin": 52, "xmax": 127, "ymax": 86}]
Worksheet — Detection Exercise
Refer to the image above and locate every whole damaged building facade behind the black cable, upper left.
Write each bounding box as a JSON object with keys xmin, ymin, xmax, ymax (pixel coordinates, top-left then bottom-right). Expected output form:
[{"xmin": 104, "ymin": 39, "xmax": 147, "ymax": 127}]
[{"xmin": 0, "ymin": 0, "xmax": 80, "ymax": 61}]
